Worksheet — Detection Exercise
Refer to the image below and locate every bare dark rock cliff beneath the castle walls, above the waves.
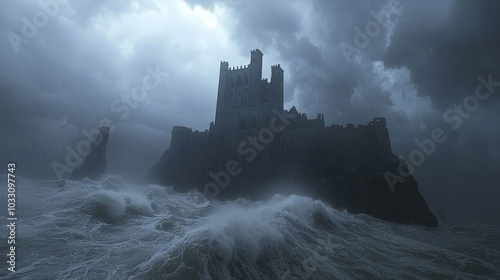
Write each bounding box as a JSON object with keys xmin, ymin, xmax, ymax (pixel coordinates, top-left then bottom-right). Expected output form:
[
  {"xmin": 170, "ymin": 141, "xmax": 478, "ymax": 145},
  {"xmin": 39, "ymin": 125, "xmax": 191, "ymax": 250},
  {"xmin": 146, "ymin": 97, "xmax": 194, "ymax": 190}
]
[{"xmin": 149, "ymin": 132, "xmax": 438, "ymax": 227}]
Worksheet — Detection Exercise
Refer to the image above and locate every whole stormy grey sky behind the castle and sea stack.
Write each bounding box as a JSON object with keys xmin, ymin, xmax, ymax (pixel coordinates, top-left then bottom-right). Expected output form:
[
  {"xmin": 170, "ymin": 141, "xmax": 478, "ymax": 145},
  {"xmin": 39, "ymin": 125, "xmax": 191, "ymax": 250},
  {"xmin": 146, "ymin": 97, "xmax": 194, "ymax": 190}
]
[{"xmin": 0, "ymin": 0, "xmax": 500, "ymax": 222}]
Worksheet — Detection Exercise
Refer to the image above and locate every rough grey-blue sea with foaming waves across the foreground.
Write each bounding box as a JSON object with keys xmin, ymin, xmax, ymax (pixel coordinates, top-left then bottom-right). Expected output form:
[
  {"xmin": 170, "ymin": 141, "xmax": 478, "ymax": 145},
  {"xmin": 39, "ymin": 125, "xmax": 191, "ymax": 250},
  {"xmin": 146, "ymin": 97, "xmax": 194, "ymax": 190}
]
[{"xmin": 0, "ymin": 175, "xmax": 500, "ymax": 280}]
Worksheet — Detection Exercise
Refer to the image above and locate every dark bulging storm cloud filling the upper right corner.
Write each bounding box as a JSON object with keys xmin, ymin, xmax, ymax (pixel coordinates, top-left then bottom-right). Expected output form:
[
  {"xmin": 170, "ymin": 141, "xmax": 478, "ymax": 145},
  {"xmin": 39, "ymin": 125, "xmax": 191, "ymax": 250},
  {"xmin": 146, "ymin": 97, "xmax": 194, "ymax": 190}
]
[{"xmin": 384, "ymin": 0, "xmax": 500, "ymax": 110}]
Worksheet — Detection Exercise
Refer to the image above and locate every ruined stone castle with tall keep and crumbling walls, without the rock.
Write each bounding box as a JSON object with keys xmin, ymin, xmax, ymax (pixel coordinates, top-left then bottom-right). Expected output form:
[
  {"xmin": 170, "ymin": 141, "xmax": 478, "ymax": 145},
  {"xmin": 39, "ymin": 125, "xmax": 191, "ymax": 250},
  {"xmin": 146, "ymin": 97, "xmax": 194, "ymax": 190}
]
[{"xmin": 171, "ymin": 49, "xmax": 392, "ymax": 153}]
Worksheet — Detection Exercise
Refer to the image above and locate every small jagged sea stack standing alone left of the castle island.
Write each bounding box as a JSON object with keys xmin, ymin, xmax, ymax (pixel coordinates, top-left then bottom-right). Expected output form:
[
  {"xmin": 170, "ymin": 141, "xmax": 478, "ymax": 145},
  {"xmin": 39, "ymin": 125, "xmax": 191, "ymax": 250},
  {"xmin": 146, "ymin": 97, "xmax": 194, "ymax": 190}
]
[{"xmin": 71, "ymin": 127, "xmax": 109, "ymax": 180}]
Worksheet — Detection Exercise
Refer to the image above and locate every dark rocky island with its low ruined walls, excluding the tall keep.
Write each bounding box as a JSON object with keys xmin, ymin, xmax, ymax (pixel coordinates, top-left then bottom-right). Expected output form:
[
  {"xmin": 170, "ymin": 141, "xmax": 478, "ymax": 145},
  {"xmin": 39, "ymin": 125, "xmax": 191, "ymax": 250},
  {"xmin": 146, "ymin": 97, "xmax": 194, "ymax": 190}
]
[{"xmin": 149, "ymin": 118, "xmax": 438, "ymax": 226}]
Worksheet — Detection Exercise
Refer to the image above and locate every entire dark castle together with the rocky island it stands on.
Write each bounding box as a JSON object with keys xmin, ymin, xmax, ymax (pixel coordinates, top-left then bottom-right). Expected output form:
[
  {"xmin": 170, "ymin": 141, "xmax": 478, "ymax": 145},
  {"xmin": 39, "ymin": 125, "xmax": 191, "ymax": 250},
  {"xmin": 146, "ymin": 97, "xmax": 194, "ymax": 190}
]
[{"xmin": 149, "ymin": 50, "xmax": 437, "ymax": 226}]
